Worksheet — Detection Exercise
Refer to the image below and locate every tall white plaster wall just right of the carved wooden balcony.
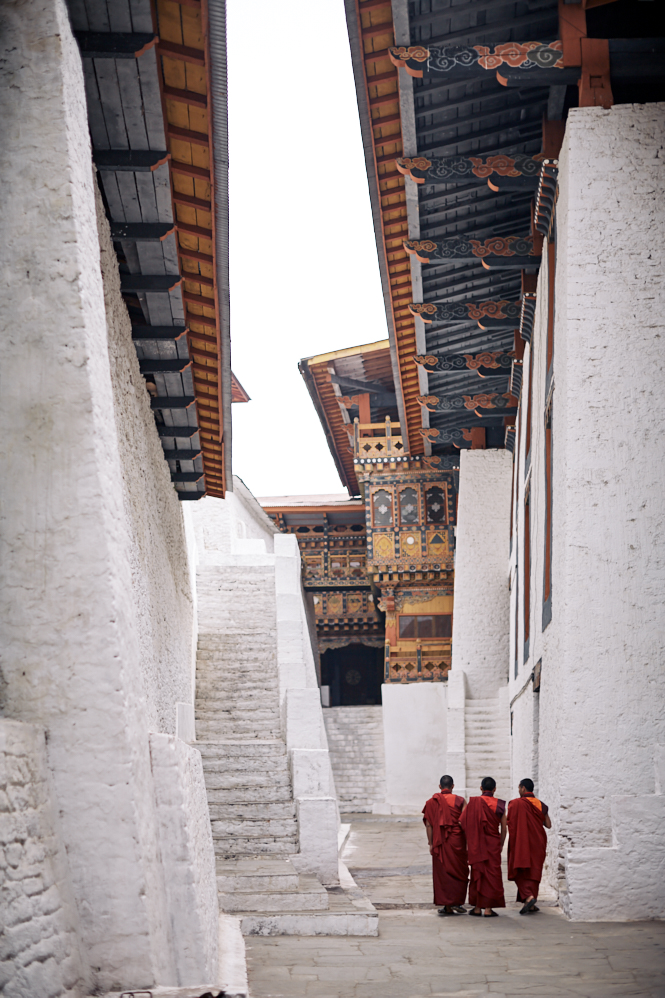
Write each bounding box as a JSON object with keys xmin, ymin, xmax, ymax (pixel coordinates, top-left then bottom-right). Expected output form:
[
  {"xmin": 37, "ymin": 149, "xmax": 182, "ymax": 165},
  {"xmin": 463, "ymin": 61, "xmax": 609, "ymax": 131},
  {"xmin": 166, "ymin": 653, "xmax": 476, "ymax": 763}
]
[{"xmin": 452, "ymin": 450, "xmax": 512, "ymax": 699}]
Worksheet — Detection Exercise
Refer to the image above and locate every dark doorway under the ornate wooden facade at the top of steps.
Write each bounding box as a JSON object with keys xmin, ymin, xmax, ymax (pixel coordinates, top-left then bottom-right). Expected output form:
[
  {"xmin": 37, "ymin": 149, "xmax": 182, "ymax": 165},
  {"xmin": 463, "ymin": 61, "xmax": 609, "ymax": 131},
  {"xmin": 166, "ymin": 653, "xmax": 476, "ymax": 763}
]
[{"xmin": 321, "ymin": 645, "xmax": 383, "ymax": 707}]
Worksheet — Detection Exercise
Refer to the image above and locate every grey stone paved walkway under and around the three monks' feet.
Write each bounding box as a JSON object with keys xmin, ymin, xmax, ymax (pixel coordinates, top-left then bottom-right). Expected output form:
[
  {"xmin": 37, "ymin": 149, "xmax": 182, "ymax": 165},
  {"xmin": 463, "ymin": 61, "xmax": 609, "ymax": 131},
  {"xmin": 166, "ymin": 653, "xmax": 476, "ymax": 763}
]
[{"xmin": 246, "ymin": 815, "xmax": 665, "ymax": 998}]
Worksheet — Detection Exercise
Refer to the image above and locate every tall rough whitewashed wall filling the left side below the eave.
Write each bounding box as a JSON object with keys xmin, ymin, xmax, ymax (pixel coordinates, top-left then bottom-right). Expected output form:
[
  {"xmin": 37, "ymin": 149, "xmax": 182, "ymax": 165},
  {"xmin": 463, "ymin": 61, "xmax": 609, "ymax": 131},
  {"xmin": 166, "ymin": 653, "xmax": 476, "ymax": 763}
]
[{"xmin": 0, "ymin": 0, "xmax": 214, "ymax": 992}]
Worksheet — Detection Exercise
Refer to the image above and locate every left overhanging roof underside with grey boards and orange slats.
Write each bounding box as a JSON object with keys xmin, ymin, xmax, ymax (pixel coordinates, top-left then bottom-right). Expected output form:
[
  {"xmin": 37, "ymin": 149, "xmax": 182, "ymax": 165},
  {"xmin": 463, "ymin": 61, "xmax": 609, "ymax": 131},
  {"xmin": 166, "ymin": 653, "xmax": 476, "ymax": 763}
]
[{"xmin": 68, "ymin": 0, "xmax": 232, "ymax": 499}]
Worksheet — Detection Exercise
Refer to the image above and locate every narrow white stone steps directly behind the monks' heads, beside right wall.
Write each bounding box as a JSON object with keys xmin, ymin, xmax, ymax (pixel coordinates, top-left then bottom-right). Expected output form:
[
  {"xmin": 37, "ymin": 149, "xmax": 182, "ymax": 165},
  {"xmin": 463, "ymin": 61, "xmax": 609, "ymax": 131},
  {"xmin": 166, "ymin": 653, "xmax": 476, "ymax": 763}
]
[{"xmin": 464, "ymin": 698, "xmax": 511, "ymax": 800}]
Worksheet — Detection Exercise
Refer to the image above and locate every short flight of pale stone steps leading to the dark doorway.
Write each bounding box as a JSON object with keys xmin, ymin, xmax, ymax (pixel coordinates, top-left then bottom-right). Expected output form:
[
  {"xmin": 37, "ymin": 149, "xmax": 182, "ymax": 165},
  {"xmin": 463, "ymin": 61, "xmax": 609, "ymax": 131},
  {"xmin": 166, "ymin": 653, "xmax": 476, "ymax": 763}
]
[{"xmin": 323, "ymin": 705, "xmax": 386, "ymax": 812}]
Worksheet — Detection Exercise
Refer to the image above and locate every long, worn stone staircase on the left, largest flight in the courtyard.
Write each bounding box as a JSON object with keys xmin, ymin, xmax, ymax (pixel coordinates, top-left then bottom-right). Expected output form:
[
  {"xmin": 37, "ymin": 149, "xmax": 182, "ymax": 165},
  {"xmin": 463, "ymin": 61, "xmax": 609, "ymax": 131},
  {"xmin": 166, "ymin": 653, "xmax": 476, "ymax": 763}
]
[{"xmin": 195, "ymin": 628, "xmax": 378, "ymax": 935}]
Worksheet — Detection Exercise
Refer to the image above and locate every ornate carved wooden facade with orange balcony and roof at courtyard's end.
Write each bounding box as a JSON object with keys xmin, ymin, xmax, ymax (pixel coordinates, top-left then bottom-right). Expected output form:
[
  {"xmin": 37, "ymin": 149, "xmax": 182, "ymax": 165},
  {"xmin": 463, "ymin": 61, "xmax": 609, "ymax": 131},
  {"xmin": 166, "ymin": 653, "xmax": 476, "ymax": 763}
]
[{"xmin": 298, "ymin": 342, "xmax": 458, "ymax": 683}]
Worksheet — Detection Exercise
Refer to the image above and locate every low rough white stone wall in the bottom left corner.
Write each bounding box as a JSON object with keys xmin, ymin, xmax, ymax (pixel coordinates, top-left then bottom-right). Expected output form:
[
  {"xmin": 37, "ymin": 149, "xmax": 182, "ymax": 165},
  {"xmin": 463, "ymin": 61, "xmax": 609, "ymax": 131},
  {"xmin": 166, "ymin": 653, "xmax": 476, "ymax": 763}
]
[{"xmin": 0, "ymin": 718, "xmax": 88, "ymax": 998}]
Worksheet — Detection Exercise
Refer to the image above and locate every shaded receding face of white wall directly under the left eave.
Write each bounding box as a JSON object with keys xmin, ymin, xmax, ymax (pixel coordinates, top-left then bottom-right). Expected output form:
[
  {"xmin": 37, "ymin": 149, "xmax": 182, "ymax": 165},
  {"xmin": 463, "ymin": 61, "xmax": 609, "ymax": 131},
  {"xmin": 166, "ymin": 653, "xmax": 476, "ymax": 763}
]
[{"xmin": 97, "ymin": 191, "xmax": 194, "ymax": 734}]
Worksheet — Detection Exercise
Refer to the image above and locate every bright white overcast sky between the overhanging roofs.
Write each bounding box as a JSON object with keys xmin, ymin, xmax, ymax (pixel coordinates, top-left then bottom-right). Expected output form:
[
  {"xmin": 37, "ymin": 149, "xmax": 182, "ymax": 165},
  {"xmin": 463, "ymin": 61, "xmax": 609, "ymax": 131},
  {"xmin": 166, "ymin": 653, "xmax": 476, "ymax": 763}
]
[{"xmin": 227, "ymin": 0, "xmax": 388, "ymax": 496}]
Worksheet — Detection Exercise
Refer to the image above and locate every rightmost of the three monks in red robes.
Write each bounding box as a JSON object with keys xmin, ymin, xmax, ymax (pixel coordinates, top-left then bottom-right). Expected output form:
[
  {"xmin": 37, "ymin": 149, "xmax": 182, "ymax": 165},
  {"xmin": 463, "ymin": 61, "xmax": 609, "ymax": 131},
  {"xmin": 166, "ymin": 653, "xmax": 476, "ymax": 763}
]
[{"xmin": 508, "ymin": 780, "xmax": 552, "ymax": 915}]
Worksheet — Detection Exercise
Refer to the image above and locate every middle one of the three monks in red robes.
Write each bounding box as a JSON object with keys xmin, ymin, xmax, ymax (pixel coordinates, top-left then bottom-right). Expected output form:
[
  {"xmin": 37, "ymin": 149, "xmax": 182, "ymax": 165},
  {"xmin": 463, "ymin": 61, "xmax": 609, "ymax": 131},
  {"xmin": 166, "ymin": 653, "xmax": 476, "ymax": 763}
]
[{"xmin": 460, "ymin": 776, "xmax": 506, "ymax": 918}]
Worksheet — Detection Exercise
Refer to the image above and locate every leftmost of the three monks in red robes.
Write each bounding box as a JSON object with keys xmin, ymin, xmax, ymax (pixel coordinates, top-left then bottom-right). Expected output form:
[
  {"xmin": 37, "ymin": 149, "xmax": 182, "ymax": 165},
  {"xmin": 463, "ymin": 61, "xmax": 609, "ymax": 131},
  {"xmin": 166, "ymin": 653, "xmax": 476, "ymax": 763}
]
[{"xmin": 423, "ymin": 776, "xmax": 469, "ymax": 915}]
